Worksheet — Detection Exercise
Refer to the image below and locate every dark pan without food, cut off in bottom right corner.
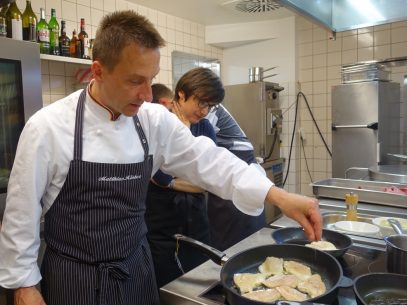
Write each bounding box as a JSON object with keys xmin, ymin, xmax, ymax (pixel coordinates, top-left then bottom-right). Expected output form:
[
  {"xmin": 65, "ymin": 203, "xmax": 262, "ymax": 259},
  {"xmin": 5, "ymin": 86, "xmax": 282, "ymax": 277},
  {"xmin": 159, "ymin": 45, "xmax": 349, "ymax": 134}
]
[{"xmin": 353, "ymin": 272, "xmax": 407, "ymax": 305}]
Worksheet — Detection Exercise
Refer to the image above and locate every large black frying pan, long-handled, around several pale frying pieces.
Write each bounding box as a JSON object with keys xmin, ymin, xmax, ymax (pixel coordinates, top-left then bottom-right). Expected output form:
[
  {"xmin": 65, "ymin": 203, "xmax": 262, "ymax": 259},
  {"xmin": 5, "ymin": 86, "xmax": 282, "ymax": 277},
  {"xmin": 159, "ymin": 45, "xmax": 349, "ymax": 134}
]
[{"xmin": 174, "ymin": 234, "xmax": 352, "ymax": 305}]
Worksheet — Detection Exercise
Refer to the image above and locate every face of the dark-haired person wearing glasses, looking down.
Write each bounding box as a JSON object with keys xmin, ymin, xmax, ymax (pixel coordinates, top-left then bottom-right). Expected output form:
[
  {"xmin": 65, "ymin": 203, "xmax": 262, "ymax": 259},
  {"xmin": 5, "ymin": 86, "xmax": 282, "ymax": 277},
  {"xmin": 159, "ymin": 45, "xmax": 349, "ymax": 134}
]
[{"xmin": 178, "ymin": 92, "xmax": 216, "ymax": 124}]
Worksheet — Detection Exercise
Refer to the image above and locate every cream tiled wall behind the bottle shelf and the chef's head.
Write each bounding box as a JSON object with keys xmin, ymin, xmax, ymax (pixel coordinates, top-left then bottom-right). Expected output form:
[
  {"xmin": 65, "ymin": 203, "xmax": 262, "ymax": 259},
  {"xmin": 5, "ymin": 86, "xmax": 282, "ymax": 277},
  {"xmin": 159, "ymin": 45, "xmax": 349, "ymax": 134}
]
[{"xmin": 17, "ymin": 0, "xmax": 222, "ymax": 105}]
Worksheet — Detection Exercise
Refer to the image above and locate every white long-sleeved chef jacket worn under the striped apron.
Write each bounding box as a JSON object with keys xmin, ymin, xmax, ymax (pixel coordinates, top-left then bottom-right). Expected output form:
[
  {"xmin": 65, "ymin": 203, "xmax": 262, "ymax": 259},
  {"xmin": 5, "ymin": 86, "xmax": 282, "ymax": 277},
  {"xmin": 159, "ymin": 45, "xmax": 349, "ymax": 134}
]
[{"xmin": 0, "ymin": 90, "xmax": 272, "ymax": 288}]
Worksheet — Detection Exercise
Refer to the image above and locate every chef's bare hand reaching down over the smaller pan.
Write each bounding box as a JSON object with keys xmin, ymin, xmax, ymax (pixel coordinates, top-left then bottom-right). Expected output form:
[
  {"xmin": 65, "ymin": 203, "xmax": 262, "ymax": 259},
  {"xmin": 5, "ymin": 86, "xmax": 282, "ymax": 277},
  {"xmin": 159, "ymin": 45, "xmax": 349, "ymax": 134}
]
[{"xmin": 266, "ymin": 186, "xmax": 322, "ymax": 240}]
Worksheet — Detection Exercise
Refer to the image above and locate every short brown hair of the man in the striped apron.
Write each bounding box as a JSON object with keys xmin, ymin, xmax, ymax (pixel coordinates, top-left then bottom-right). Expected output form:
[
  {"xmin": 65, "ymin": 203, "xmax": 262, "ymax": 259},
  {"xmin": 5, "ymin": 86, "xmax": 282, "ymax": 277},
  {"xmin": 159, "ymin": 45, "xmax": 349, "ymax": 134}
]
[{"xmin": 92, "ymin": 10, "xmax": 165, "ymax": 71}]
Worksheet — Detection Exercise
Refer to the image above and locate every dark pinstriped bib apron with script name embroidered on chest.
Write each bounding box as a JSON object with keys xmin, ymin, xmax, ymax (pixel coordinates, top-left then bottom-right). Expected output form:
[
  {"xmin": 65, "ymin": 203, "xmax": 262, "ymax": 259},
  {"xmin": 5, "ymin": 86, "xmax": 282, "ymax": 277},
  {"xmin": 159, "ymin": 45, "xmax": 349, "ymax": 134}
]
[{"xmin": 41, "ymin": 90, "xmax": 159, "ymax": 305}]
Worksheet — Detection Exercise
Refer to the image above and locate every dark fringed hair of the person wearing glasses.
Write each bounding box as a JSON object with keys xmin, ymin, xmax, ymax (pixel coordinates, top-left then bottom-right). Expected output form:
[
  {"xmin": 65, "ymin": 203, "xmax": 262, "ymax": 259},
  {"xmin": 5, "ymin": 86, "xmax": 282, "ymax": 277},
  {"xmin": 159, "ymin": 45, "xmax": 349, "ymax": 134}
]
[{"xmin": 174, "ymin": 67, "xmax": 225, "ymax": 104}]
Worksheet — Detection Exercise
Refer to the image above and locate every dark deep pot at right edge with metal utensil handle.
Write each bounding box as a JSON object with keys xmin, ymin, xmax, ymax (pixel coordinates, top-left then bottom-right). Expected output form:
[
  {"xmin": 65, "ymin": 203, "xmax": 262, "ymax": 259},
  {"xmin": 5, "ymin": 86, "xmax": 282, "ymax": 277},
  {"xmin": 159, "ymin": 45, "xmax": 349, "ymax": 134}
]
[{"xmin": 384, "ymin": 219, "xmax": 407, "ymax": 274}]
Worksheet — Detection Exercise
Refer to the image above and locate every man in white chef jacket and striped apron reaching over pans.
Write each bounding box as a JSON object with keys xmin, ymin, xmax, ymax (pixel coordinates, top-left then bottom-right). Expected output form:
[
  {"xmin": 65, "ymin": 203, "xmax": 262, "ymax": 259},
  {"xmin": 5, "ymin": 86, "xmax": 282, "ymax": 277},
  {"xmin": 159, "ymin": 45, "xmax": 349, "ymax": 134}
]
[{"xmin": 0, "ymin": 11, "xmax": 322, "ymax": 305}]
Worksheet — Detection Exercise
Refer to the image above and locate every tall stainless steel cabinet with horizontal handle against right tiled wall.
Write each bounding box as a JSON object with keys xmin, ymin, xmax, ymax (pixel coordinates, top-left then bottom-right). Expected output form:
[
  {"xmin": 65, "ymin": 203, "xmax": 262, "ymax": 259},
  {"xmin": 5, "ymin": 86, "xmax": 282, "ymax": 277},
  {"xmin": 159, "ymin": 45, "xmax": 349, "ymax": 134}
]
[{"xmin": 332, "ymin": 81, "xmax": 401, "ymax": 178}]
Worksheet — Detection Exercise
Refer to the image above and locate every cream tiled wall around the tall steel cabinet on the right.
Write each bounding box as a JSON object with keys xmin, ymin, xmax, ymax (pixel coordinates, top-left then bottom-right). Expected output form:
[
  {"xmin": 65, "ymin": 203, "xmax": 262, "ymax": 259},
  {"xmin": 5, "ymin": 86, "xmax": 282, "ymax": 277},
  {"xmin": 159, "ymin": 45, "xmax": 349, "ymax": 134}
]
[{"xmin": 296, "ymin": 18, "xmax": 407, "ymax": 195}]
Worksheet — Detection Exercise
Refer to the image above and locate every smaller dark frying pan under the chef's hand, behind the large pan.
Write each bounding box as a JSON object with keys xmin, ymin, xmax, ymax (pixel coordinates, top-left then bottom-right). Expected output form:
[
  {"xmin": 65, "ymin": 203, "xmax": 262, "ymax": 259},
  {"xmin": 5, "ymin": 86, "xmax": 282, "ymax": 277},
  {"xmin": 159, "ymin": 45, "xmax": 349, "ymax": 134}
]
[{"xmin": 271, "ymin": 227, "xmax": 352, "ymax": 258}]
